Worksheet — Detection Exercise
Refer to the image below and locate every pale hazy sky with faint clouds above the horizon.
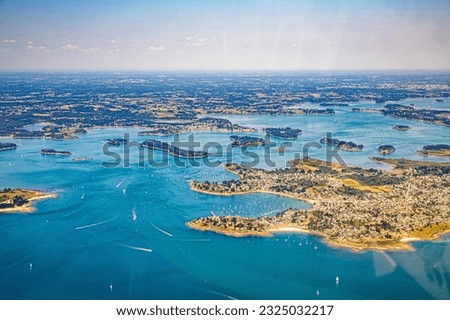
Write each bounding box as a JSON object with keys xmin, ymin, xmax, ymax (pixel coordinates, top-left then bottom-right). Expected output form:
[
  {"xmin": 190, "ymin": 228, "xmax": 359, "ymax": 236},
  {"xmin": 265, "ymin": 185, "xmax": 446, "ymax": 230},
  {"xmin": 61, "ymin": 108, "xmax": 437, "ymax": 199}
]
[{"xmin": 0, "ymin": 0, "xmax": 450, "ymax": 71}]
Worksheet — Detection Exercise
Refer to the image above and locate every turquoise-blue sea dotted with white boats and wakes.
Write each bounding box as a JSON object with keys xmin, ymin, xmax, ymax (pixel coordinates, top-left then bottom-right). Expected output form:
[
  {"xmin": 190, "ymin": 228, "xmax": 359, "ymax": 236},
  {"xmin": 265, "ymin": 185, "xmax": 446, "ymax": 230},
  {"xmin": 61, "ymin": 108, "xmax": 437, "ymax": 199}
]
[{"xmin": 0, "ymin": 100, "xmax": 450, "ymax": 299}]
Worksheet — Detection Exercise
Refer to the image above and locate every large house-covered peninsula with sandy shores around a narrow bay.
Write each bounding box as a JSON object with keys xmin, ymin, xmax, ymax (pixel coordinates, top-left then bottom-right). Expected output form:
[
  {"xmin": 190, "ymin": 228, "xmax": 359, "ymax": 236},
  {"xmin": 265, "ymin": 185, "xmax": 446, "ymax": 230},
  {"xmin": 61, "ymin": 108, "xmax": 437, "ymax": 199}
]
[{"xmin": 187, "ymin": 158, "xmax": 450, "ymax": 251}]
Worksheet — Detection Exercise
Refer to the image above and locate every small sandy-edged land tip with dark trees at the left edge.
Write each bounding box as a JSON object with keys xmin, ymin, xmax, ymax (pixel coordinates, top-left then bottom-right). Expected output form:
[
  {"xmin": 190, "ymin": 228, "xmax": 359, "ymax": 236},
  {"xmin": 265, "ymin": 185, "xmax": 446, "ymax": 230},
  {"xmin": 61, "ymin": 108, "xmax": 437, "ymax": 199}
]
[{"xmin": 0, "ymin": 188, "xmax": 57, "ymax": 213}]
